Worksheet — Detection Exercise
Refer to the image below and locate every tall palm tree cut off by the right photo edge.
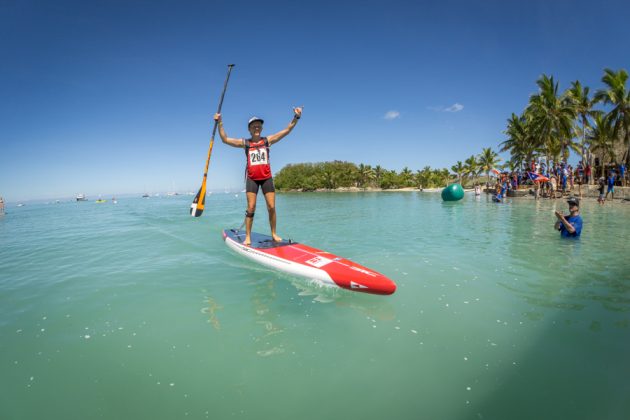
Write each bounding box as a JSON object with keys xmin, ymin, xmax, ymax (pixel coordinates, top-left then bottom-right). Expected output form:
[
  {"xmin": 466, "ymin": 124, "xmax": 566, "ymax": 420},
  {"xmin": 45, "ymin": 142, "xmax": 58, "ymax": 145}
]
[{"xmin": 595, "ymin": 69, "xmax": 630, "ymax": 161}]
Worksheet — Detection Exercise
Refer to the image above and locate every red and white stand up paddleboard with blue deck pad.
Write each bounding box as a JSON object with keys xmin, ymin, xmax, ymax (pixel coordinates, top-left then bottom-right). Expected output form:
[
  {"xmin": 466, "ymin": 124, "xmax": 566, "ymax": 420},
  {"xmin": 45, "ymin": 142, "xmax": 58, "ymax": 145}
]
[{"xmin": 223, "ymin": 229, "xmax": 396, "ymax": 295}]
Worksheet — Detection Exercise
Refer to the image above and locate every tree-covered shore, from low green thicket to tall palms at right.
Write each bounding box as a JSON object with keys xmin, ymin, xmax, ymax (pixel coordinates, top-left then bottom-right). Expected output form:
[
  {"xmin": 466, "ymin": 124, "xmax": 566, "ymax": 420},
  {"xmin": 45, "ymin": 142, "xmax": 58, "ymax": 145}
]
[{"xmin": 274, "ymin": 69, "xmax": 630, "ymax": 191}]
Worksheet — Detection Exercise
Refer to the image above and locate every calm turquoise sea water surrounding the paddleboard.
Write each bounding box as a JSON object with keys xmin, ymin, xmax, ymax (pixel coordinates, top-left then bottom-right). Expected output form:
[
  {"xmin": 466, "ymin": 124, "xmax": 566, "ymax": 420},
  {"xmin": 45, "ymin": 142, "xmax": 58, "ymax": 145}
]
[{"xmin": 0, "ymin": 192, "xmax": 630, "ymax": 419}]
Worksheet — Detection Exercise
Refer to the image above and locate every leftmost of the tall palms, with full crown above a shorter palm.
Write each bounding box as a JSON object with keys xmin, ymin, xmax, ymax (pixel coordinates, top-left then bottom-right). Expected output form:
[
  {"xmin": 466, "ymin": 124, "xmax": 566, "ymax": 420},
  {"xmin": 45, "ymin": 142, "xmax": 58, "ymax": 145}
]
[{"xmin": 526, "ymin": 74, "xmax": 576, "ymax": 163}]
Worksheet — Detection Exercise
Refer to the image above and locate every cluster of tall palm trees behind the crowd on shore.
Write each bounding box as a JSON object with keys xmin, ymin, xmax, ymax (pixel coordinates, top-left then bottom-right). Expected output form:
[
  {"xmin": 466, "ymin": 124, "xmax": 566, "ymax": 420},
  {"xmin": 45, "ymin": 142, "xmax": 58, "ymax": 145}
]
[{"xmin": 500, "ymin": 69, "xmax": 630, "ymax": 182}]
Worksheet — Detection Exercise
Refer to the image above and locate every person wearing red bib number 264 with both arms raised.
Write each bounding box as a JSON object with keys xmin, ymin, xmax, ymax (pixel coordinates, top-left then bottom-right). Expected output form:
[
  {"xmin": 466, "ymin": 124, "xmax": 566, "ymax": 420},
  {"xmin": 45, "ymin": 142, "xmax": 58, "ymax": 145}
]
[{"xmin": 214, "ymin": 107, "xmax": 302, "ymax": 245}]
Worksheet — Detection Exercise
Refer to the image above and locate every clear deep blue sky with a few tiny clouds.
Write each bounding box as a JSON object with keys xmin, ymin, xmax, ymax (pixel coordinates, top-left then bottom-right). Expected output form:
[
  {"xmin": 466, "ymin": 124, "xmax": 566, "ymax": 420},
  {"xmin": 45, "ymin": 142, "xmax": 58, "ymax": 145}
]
[{"xmin": 0, "ymin": 0, "xmax": 630, "ymax": 201}]
